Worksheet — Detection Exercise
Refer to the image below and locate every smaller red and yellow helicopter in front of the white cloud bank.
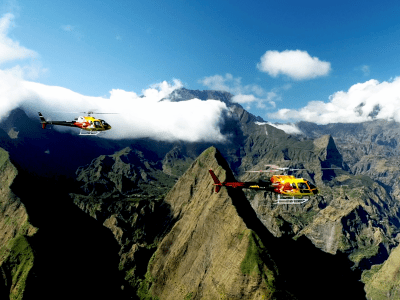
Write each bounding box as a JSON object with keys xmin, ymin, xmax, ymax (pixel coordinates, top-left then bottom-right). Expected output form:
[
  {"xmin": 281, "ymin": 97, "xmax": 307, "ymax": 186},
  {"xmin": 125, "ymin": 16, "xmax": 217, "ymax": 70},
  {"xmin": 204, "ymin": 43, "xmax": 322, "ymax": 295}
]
[{"xmin": 39, "ymin": 111, "xmax": 111, "ymax": 135}]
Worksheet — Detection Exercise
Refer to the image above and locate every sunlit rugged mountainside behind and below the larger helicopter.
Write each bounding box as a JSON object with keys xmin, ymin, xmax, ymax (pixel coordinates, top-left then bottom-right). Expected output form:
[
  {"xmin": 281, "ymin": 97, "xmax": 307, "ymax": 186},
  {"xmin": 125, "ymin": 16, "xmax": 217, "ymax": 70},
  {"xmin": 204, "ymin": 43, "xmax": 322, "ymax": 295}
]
[{"xmin": 241, "ymin": 128, "xmax": 400, "ymax": 270}]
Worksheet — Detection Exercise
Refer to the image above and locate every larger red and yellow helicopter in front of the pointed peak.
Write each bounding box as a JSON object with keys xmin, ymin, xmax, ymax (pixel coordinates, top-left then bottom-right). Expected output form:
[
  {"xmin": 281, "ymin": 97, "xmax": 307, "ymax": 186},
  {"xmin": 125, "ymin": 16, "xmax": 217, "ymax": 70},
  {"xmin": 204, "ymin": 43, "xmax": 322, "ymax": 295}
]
[{"xmin": 209, "ymin": 165, "xmax": 318, "ymax": 204}]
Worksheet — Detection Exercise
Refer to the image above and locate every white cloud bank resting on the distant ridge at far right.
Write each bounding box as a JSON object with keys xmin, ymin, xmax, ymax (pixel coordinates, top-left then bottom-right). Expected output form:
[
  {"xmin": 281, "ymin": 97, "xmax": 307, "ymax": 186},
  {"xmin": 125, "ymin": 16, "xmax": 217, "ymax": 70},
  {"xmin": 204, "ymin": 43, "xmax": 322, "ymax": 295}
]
[{"xmin": 268, "ymin": 77, "xmax": 400, "ymax": 124}]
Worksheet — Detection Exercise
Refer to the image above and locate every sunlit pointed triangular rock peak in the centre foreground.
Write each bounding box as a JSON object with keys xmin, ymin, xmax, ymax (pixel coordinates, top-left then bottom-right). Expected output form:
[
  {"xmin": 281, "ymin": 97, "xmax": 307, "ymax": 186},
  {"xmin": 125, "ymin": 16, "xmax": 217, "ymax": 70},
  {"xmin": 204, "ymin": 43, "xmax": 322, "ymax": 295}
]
[{"xmin": 139, "ymin": 148, "xmax": 289, "ymax": 299}]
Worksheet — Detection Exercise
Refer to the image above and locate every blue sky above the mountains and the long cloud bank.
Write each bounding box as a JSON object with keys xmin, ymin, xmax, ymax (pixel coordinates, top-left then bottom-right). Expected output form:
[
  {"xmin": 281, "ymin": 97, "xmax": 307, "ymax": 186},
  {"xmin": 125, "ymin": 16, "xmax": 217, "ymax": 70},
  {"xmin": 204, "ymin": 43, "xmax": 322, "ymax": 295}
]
[{"xmin": 0, "ymin": 0, "xmax": 400, "ymax": 138}]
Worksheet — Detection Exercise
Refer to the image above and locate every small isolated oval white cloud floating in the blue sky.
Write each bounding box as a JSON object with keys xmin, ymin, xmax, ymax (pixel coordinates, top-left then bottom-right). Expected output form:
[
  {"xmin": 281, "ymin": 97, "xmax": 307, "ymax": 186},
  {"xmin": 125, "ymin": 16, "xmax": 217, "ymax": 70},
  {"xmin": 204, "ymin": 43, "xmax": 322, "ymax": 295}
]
[{"xmin": 257, "ymin": 50, "xmax": 331, "ymax": 80}]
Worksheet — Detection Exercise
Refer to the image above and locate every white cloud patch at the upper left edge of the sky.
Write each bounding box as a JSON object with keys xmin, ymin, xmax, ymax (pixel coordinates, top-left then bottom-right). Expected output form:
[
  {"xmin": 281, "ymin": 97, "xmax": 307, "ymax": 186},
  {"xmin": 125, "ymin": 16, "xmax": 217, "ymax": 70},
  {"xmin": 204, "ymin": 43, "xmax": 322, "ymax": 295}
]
[{"xmin": 0, "ymin": 13, "xmax": 37, "ymax": 64}]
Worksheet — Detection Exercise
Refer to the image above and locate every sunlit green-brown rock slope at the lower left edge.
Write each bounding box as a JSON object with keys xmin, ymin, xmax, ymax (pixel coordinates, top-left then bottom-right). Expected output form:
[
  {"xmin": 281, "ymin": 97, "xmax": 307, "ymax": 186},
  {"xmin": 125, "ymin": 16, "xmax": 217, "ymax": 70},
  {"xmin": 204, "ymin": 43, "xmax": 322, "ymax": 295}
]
[{"xmin": 0, "ymin": 148, "xmax": 37, "ymax": 299}]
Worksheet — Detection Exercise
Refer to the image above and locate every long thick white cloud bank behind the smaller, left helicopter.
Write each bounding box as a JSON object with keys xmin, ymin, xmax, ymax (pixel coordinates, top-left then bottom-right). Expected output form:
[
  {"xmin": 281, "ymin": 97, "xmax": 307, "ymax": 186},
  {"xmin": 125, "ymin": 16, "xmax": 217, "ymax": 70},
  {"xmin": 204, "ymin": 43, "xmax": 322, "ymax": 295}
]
[{"xmin": 0, "ymin": 71, "xmax": 227, "ymax": 142}]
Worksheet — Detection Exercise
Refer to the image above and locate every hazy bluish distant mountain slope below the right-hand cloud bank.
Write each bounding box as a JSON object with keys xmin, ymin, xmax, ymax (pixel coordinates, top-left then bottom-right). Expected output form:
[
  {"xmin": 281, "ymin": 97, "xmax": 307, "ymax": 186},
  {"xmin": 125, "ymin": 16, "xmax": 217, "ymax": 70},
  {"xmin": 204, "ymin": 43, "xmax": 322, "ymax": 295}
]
[{"xmin": 297, "ymin": 120, "xmax": 400, "ymax": 200}]
